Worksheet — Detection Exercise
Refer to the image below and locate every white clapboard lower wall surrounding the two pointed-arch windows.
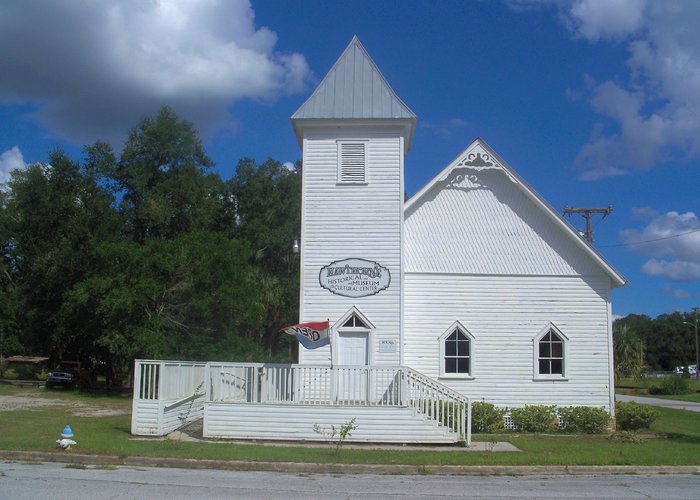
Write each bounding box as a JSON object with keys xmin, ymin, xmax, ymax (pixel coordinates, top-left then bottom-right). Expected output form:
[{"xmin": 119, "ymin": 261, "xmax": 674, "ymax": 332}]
[{"xmin": 404, "ymin": 273, "xmax": 612, "ymax": 409}]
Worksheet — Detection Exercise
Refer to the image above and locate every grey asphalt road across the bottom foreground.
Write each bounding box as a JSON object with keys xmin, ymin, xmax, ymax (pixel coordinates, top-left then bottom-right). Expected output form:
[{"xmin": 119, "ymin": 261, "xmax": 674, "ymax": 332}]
[{"xmin": 0, "ymin": 462, "xmax": 700, "ymax": 500}]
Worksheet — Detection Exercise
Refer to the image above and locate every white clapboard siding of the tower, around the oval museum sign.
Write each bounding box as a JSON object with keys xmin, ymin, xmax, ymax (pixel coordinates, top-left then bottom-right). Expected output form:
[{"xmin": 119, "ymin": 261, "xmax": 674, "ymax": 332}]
[{"xmin": 299, "ymin": 126, "xmax": 403, "ymax": 365}]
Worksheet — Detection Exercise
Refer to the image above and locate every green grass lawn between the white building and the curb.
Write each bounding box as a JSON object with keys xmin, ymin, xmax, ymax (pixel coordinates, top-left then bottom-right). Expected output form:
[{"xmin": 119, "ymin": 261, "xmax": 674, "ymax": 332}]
[{"xmin": 0, "ymin": 385, "xmax": 700, "ymax": 465}]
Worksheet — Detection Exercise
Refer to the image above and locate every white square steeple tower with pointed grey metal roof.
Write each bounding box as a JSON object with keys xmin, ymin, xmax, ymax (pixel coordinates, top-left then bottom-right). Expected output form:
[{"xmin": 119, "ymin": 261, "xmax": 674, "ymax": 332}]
[{"xmin": 292, "ymin": 37, "xmax": 416, "ymax": 365}]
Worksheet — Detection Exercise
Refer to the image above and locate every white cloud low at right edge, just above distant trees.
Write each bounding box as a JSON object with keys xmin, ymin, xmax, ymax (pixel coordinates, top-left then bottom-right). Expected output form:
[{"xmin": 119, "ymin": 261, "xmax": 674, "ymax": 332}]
[{"xmin": 621, "ymin": 212, "xmax": 700, "ymax": 281}]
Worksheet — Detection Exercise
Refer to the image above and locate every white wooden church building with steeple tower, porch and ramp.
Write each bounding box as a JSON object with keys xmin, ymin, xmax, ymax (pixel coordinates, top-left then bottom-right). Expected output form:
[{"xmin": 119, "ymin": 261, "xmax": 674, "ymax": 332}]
[{"xmin": 132, "ymin": 38, "xmax": 625, "ymax": 442}]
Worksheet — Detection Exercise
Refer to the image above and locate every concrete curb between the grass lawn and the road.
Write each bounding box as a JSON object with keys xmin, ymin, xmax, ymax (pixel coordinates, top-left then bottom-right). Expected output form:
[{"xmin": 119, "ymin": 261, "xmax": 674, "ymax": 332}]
[{"xmin": 0, "ymin": 451, "xmax": 700, "ymax": 476}]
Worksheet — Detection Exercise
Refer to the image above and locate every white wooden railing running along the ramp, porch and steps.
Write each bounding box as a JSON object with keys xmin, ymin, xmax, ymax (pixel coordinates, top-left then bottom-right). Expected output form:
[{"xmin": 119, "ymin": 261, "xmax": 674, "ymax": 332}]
[{"xmin": 132, "ymin": 360, "xmax": 471, "ymax": 444}]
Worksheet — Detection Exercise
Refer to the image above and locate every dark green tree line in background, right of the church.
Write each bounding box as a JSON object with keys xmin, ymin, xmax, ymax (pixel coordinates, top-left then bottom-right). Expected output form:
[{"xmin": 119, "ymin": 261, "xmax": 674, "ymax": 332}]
[{"xmin": 613, "ymin": 312, "xmax": 700, "ymax": 379}]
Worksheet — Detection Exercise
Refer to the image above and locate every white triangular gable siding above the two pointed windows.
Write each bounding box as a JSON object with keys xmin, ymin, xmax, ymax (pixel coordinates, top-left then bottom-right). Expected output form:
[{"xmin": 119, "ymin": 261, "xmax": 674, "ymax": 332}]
[{"xmin": 405, "ymin": 156, "xmax": 602, "ymax": 276}]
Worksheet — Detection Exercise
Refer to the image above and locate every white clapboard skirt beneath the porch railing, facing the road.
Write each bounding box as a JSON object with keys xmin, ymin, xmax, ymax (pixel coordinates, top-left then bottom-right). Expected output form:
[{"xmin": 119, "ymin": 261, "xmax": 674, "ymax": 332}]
[{"xmin": 203, "ymin": 402, "xmax": 459, "ymax": 443}]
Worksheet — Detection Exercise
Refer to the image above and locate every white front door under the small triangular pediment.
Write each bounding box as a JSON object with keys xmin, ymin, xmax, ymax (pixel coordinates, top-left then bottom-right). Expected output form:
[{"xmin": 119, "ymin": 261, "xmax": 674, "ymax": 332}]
[{"xmin": 337, "ymin": 332, "xmax": 369, "ymax": 401}]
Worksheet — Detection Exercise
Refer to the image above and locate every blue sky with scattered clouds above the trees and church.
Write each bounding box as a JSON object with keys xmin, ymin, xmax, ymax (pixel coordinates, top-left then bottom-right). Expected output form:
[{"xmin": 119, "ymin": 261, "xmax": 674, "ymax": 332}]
[{"xmin": 0, "ymin": 0, "xmax": 700, "ymax": 316}]
